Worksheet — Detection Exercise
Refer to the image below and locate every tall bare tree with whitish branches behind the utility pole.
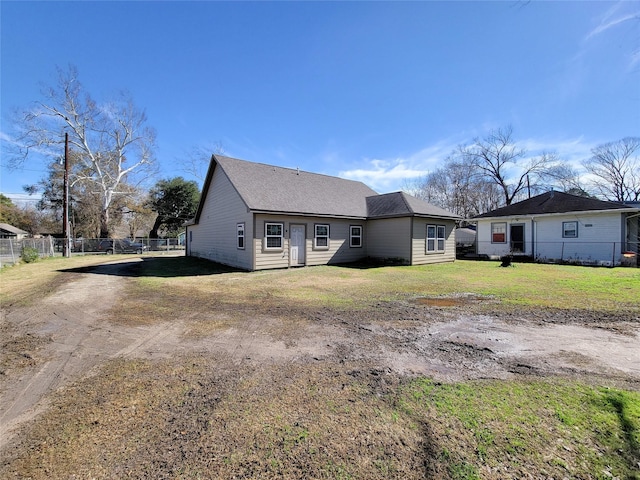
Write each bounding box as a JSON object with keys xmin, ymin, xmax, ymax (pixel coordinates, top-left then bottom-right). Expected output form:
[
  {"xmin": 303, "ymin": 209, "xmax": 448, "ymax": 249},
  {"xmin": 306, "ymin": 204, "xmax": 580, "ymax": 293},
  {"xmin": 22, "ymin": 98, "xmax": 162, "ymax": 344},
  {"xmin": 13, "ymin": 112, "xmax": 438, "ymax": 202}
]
[{"xmin": 10, "ymin": 66, "xmax": 155, "ymax": 237}]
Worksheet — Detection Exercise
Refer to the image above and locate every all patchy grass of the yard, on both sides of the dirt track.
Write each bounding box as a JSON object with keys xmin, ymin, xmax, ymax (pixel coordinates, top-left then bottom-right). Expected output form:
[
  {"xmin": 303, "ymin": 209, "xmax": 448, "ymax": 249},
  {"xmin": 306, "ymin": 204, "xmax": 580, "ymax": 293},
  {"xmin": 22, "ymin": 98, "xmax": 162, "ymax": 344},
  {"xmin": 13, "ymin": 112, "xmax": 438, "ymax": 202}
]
[{"xmin": 0, "ymin": 256, "xmax": 640, "ymax": 480}]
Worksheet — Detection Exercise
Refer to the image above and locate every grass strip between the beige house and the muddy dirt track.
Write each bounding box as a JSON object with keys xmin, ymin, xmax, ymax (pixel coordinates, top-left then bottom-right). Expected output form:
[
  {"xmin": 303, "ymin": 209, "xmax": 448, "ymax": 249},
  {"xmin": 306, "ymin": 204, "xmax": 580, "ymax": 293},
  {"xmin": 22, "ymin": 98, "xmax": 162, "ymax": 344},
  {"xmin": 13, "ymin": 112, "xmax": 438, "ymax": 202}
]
[{"xmin": 132, "ymin": 258, "xmax": 640, "ymax": 314}]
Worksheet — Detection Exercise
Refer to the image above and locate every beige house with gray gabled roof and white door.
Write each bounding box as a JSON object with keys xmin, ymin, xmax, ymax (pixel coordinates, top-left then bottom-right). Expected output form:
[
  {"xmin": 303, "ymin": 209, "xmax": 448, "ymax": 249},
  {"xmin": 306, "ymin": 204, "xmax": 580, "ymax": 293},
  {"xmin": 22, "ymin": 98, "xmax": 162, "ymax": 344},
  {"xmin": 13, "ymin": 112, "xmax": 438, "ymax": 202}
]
[{"xmin": 186, "ymin": 155, "xmax": 460, "ymax": 270}]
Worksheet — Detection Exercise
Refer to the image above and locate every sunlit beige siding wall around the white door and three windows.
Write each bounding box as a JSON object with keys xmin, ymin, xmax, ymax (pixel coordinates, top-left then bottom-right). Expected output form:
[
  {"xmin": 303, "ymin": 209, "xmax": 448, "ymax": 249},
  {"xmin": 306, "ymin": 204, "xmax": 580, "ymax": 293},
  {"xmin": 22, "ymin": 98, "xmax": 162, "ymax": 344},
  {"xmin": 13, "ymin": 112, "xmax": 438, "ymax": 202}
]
[{"xmin": 253, "ymin": 214, "xmax": 367, "ymax": 270}]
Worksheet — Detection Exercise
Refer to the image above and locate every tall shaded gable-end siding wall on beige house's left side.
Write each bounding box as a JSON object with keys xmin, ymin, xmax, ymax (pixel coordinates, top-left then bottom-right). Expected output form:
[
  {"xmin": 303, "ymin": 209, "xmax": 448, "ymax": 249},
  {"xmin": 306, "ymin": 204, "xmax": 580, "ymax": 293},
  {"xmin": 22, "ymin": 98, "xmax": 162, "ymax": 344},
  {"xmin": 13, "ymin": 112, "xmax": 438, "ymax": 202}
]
[{"xmin": 190, "ymin": 168, "xmax": 253, "ymax": 270}]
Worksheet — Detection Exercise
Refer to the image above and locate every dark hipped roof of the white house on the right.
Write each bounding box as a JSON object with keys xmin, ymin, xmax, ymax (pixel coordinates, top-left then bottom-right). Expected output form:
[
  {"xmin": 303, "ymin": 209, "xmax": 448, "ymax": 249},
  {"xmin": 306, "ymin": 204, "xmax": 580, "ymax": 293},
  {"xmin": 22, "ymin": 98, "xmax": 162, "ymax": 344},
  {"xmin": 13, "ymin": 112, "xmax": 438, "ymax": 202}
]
[{"xmin": 473, "ymin": 191, "xmax": 629, "ymax": 218}]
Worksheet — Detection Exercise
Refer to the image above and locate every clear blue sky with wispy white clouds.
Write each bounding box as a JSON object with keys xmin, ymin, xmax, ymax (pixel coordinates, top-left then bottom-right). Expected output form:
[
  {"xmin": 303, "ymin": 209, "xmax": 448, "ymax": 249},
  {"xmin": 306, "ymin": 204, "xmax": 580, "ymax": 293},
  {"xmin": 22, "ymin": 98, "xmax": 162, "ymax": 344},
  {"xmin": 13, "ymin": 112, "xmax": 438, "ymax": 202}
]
[{"xmin": 0, "ymin": 0, "xmax": 640, "ymax": 204}]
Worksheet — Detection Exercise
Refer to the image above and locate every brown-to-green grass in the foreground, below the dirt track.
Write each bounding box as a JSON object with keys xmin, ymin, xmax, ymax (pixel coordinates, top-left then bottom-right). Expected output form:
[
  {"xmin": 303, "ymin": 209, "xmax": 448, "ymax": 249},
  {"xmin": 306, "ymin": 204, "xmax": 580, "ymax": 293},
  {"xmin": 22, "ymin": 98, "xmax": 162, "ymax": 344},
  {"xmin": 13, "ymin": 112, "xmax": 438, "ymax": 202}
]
[{"xmin": 0, "ymin": 357, "xmax": 640, "ymax": 480}]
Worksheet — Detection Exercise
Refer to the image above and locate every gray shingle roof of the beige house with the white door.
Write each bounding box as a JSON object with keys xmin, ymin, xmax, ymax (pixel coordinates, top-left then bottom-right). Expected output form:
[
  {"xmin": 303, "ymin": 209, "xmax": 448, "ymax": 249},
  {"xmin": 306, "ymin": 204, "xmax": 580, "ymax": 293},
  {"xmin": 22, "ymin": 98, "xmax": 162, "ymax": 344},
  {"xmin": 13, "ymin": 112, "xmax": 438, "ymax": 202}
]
[{"xmin": 195, "ymin": 155, "xmax": 460, "ymax": 223}]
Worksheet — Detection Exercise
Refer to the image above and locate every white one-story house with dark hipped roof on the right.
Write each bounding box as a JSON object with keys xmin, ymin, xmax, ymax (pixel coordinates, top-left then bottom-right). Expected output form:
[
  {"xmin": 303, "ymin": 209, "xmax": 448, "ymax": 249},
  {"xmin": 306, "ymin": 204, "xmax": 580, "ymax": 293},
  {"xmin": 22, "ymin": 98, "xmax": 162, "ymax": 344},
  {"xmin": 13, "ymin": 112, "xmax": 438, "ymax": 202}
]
[{"xmin": 473, "ymin": 191, "xmax": 640, "ymax": 265}]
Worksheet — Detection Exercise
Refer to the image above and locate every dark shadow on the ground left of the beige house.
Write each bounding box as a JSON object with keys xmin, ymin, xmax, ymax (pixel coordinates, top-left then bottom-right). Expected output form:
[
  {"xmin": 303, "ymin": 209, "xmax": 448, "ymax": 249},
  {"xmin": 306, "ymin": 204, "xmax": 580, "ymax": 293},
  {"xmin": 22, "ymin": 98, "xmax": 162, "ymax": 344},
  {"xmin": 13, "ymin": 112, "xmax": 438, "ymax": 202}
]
[{"xmin": 58, "ymin": 257, "xmax": 243, "ymax": 278}]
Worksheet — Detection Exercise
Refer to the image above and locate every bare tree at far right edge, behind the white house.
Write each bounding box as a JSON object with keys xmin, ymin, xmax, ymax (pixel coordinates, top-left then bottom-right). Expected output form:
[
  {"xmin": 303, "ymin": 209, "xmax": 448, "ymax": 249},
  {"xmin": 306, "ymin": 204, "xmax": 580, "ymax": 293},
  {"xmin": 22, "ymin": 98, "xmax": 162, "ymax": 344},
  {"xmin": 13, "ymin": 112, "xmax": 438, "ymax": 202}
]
[{"xmin": 584, "ymin": 137, "xmax": 640, "ymax": 202}]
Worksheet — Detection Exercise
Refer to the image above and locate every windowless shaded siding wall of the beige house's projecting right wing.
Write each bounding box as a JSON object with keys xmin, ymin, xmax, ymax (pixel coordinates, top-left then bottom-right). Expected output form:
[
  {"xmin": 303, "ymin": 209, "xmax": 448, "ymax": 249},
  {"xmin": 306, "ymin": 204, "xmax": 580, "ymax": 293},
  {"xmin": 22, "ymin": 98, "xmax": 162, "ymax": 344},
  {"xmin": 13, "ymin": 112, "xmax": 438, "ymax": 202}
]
[{"xmin": 365, "ymin": 217, "xmax": 411, "ymax": 263}]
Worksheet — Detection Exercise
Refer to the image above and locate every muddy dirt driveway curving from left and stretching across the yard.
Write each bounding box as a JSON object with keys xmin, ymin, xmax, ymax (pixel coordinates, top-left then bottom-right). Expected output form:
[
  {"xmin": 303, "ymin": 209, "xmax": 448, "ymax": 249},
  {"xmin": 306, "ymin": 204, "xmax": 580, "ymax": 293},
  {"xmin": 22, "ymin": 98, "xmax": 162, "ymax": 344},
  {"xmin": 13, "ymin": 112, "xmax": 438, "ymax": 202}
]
[{"xmin": 0, "ymin": 259, "xmax": 640, "ymax": 449}]
